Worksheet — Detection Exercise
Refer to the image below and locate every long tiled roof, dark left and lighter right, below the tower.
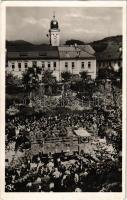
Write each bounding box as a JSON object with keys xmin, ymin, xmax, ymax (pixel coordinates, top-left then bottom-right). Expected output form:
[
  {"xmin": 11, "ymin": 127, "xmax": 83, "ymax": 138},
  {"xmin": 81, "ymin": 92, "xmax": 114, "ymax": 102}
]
[{"xmin": 7, "ymin": 45, "xmax": 95, "ymax": 60}]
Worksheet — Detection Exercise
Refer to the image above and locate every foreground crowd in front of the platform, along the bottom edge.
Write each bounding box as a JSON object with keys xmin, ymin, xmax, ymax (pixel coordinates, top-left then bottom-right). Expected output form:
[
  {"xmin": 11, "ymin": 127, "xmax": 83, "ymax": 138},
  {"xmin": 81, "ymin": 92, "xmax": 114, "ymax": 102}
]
[{"xmin": 5, "ymin": 147, "xmax": 121, "ymax": 192}]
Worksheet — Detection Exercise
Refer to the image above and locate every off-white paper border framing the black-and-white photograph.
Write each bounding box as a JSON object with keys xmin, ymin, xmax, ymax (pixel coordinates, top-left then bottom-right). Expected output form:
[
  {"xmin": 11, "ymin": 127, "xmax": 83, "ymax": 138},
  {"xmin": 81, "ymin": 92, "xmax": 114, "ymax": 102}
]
[{"xmin": 0, "ymin": 1, "xmax": 127, "ymax": 200}]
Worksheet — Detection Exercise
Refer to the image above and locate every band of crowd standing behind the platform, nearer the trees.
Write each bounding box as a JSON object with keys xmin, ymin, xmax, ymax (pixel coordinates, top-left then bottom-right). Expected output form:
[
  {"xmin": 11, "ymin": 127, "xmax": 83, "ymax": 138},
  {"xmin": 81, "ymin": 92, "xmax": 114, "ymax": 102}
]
[{"xmin": 6, "ymin": 105, "xmax": 121, "ymax": 148}]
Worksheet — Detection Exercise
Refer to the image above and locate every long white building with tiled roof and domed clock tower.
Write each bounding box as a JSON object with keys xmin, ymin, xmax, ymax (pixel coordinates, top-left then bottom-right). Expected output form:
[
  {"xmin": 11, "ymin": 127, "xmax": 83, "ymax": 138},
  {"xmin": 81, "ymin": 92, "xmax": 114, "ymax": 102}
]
[{"xmin": 6, "ymin": 15, "xmax": 96, "ymax": 81}]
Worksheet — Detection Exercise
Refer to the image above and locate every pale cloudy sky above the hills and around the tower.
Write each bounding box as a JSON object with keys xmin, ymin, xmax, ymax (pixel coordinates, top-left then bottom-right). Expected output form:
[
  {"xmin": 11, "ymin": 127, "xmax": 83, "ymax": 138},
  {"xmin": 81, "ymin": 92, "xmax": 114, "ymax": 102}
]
[{"xmin": 6, "ymin": 7, "xmax": 122, "ymax": 44}]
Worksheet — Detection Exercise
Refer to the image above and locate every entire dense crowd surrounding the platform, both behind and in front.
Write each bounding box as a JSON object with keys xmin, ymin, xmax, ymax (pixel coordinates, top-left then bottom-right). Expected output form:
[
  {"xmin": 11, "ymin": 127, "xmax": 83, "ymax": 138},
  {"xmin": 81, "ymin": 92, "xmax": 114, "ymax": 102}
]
[{"xmin": 5, "ymin": 81, "xmax": 122, "ymax": 192}]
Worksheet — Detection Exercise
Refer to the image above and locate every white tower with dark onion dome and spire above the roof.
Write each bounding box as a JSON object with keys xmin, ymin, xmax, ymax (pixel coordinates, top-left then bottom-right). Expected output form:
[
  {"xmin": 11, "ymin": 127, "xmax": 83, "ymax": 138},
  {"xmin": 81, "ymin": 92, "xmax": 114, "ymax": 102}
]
[{"xmin": 49, "ymin": 14, "xmax": 60, "ymax": 46}]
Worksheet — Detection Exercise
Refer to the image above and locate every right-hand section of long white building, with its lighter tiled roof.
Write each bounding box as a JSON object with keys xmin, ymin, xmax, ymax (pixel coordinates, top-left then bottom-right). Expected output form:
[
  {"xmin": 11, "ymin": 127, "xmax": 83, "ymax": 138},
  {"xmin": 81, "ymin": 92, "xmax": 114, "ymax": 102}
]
[{"xmin": 58, "ymin": 46, "xmax": 96, "ymax": 79}]
